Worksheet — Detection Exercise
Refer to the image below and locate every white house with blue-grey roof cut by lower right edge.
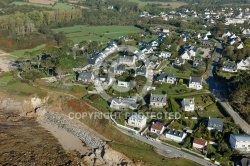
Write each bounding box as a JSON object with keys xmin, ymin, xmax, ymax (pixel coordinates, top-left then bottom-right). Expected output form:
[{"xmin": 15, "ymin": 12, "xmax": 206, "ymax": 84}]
[{"xmin": 229, "ymin": 134, "xmax": 250, "ymax": 152}]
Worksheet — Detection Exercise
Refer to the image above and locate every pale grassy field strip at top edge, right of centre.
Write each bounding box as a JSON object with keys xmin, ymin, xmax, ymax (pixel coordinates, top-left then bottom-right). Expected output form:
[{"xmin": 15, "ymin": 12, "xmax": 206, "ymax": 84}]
[{"xmin": 129, "ymin": 0, "xmax": 187, "ymax": 9}]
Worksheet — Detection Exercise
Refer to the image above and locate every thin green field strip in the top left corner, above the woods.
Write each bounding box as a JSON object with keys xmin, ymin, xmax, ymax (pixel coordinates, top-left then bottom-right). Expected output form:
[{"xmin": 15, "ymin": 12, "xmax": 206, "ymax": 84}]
[{"xmin": 11, "ymin": 1, "xmax": 74, "ymax": 10}]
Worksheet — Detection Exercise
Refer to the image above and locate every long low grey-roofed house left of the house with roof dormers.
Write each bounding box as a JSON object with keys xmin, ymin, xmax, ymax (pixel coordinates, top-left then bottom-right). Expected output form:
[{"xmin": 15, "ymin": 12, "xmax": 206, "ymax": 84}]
[{"xmin": 110, "ymin": 97, "xmax": 138, "ymax": 110}]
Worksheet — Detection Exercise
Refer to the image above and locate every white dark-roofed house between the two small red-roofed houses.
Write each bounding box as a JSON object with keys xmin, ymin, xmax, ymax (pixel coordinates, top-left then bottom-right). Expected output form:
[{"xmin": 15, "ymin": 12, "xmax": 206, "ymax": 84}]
[{"xmin": 163, "ymin": 128, "xmax": 187, "ymax": 142}]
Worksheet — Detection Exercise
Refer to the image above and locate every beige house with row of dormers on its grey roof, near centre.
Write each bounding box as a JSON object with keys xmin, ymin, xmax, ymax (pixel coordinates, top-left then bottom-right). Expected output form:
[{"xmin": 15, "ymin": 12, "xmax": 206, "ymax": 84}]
[{"xmin": 150, "ymin": 94, "xmax": 167, "ymax": 108}]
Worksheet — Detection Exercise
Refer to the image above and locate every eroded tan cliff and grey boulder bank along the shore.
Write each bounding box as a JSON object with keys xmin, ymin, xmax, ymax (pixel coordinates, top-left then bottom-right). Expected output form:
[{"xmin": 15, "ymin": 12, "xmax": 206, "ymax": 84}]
[{"xmin": 0, "ymin": 92, "xmax": 134, "ymax": 166}]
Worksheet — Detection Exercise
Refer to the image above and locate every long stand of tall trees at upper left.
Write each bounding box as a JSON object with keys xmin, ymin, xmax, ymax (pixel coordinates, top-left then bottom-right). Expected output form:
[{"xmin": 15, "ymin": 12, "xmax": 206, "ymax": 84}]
[{"xmin": 0, "ymin": 9, "xmax": 82, "ymax": 35}]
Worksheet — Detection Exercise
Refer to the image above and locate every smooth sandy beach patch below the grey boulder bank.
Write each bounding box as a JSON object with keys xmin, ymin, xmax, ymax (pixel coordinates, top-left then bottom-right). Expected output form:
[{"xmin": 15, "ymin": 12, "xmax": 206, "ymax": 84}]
[{"xmin": 37, "ymin": 118, "xmax": 88, "ymax": 154}]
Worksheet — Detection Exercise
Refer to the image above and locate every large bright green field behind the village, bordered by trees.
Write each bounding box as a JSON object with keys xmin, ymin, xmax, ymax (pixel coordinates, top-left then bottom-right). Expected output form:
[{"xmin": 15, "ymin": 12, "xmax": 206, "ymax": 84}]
[{"xmin": 53, "ymin": 25, "xmax": 141, "ymax": 43}]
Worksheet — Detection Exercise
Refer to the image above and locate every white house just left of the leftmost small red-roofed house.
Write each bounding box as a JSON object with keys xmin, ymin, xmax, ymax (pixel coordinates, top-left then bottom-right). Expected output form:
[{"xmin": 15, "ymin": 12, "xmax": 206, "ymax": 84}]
[{"xmin": 128, "ymin": 114, "xmax": 147, "ymax": 129}]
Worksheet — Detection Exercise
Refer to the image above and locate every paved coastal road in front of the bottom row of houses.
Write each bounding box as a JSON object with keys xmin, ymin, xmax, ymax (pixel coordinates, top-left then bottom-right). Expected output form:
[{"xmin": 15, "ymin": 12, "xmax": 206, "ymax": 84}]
[{"xmin": 116, "ymin": 127, "xmax": 215, "ymax": 166}]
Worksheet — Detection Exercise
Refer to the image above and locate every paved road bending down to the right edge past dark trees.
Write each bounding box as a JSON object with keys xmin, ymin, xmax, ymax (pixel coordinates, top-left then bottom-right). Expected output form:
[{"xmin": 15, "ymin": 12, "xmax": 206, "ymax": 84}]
[{"xmin": 206, "ymin": 42, "xmax": 250, "ymax": 134}]
